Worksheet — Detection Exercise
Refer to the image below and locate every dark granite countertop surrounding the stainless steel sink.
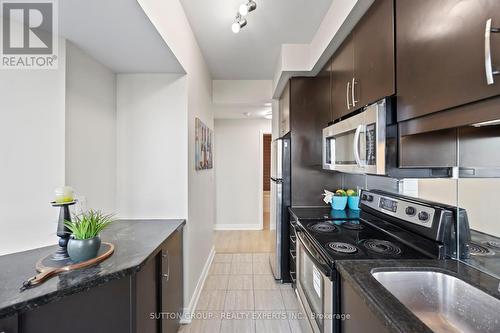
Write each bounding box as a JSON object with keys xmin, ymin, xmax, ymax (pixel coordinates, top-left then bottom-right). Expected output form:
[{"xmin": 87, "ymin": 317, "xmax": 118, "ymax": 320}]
[{"xmin": 336, "ymin": 259, "xmax": 500, "ymax": 333}]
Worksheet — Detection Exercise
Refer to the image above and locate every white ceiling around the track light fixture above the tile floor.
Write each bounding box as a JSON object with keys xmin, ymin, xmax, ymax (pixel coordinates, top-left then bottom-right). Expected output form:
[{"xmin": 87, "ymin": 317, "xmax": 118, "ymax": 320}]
[{"xmin": 181, "ymin": 0, "xmax": 332, "ymax": 80}]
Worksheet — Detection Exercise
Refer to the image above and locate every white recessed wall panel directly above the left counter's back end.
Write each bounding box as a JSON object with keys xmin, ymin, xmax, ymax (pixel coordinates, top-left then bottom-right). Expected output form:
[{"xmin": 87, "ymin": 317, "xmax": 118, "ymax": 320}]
[{"xmin": 117, "ymin": 74, "xmax": 188, "ymax": 218}]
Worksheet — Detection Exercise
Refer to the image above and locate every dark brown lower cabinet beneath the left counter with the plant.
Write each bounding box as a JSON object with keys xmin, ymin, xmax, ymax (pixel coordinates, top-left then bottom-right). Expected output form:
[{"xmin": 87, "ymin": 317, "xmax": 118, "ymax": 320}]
[{"xmin": 15, "ymin": 228, "xmax": 183, "ymax": 333}]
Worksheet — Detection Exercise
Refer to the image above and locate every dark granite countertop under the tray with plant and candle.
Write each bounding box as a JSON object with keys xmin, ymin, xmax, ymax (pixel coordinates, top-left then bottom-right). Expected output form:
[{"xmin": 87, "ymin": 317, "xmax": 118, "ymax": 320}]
[{"xmin": 0, "ymin": 220, "xmax": 185, "ymax": 318}]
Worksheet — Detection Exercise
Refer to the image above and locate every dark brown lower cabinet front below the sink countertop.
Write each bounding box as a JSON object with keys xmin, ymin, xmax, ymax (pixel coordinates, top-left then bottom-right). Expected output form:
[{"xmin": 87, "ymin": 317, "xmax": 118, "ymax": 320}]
[{"xmin": 340, "ymin": 279, "xmax": 389, "ymax": 333}]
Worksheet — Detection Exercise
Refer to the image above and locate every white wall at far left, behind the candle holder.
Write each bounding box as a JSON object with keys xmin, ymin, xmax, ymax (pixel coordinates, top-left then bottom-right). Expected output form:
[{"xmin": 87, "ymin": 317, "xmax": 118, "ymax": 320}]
[{"xmin": 0, "ymin": 40, "xmax": 65, "ymax": 255}]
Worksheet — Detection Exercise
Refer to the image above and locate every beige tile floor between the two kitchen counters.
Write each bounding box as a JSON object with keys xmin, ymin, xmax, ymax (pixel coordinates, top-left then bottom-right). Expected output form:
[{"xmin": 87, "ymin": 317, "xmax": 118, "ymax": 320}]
[{"xmin": 179, "ymin": 253, "xmax": 302, "ymax": 333}]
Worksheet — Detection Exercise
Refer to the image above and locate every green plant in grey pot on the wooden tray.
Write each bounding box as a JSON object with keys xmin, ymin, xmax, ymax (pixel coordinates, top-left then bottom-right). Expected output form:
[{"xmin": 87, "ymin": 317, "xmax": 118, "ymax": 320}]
[{"xmin": 64, "ymin": 209, "xmax": 114, "ymax": 262}]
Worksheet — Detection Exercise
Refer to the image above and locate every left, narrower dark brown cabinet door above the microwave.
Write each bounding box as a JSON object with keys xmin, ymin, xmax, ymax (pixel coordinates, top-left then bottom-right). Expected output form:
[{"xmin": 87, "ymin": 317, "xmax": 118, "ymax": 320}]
[{"xmin": 331, "ymin": 36, "xmax": 354, "ymax": 120}]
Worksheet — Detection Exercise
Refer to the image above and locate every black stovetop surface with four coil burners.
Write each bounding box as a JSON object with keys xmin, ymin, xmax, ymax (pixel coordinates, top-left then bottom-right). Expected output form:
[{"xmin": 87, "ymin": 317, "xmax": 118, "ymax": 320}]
[{"xmin": 299, "ymin": 219, "xmax": 428, "ymax": 265}]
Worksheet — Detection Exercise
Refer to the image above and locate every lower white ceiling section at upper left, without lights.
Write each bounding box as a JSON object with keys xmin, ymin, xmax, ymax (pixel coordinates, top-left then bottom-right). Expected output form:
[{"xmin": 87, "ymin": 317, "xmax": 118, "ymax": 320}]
[{"xmin": 58, "ymin": 0, "xmax": 184, "ymax": 73}]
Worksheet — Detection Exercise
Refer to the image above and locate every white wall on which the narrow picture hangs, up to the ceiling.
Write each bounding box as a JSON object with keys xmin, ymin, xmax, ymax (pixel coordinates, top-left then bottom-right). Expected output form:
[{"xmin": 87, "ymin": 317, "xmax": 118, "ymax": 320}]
[{"xmin": 138, "ymin": 0, "xmax": 215, "ymax": 310}]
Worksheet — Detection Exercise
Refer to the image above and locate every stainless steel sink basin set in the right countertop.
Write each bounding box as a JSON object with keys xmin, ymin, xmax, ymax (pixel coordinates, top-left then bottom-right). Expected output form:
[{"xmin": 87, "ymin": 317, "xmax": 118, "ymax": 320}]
[{"xmin": 372, "ymin": 271, "xmax": 500, "ymax": 333}]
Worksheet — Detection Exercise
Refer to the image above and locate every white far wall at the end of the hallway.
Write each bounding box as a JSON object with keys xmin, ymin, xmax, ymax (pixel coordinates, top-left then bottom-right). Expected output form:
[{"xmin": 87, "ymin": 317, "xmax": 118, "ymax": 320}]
[{"xmin": 214, "ymin": 119, "xmax": 272, "ymax": 230}]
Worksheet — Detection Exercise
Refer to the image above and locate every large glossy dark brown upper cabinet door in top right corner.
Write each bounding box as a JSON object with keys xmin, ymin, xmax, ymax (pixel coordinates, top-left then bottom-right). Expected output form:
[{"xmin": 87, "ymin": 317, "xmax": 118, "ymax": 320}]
[{"xmin": 396, "ymin": 0, "xmax": 500, "ymax": 121}]
